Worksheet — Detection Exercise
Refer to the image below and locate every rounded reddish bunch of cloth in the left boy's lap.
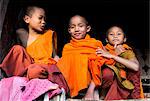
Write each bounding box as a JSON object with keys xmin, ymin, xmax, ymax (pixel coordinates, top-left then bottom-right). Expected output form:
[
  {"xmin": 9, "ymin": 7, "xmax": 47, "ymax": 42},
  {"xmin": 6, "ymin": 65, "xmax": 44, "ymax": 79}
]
[{"xmin": 27, "ymin": 64, "xmax": 48, "ymax": 79}]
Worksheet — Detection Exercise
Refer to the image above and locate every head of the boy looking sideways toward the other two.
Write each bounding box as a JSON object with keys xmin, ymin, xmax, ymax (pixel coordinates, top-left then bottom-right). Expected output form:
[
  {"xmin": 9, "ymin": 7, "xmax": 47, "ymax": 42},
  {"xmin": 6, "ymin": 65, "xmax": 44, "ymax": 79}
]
[{"xmin": 26, "ymin": 8, "xmax": 46, "ymax": 32}]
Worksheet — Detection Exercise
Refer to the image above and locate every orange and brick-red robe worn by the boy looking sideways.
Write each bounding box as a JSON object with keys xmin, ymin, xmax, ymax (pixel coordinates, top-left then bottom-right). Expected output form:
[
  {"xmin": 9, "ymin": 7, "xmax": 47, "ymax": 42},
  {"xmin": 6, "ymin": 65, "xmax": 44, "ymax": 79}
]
[{"xmin": 0, "ymin": 30, "xmax": 69, "ymax": 92}]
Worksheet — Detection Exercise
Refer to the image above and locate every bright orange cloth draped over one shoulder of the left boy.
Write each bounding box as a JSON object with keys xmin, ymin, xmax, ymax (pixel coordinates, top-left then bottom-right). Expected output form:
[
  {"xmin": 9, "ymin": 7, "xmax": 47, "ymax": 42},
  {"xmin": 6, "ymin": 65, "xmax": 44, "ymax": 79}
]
[{"xmin": 26, "ymin": 30, "xmax": 56, "ymax": 64}]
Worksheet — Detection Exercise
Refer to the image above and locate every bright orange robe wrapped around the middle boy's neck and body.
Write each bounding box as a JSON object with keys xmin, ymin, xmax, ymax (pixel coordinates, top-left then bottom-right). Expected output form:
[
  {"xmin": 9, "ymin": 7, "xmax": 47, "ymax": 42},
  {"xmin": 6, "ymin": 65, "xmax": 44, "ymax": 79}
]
[{"xmin": 57, "ymin": 35, "xmax": 113, "ymax": 97}]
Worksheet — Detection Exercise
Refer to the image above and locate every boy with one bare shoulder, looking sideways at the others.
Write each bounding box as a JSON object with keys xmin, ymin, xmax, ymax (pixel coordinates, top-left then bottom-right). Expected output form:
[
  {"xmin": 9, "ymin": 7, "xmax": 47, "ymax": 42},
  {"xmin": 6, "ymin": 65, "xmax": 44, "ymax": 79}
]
[{"xmin": 0, "ymin": 6, "xmax": 68, "ymax": 99}]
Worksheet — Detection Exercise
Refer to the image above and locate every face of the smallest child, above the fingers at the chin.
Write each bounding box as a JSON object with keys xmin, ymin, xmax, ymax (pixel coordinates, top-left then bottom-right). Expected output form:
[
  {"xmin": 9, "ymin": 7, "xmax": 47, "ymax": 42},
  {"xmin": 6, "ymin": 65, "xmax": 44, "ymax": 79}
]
[{"xmin": 107, "ymin": 26, "xmax": 125, "ymax": 45}]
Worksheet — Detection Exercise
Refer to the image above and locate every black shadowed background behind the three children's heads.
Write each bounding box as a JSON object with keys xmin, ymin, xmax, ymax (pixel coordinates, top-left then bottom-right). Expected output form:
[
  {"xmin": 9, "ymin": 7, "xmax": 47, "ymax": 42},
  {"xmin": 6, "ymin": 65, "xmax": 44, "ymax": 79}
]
[{"xmin": 2, "ymin": 0, "xmax": 149, "ymax": 55}]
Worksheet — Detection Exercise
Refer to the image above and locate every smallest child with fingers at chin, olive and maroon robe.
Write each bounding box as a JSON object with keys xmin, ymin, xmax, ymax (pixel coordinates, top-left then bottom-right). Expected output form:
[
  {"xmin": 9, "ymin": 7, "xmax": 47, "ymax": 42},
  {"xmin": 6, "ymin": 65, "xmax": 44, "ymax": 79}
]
[{"xmin": 96, "ymin": 26, "xmax": 143, "ymax": 100}]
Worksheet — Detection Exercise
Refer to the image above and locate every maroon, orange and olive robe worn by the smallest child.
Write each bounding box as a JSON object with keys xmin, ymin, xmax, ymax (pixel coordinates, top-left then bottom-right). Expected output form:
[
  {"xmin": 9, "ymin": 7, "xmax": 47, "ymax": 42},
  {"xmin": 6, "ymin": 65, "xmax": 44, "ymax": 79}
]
[{"xmin": 102, "ymin": 44, "xmax": 143, "ymax": 100}]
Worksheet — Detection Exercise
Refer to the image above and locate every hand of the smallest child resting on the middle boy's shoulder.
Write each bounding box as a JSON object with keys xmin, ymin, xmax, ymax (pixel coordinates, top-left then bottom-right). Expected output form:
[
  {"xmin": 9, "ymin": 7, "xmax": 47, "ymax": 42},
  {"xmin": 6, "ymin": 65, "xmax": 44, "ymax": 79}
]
[{"xmin": 96, "ymin": 47, "xmax": 113, "ymax": 58}]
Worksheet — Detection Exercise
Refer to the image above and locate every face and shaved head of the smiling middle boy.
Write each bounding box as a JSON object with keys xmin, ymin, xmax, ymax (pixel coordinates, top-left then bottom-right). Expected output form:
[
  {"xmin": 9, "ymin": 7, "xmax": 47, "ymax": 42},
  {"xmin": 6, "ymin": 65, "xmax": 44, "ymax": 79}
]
[{"xmin": 68, "ymin": 16, "xmax": 90, "ymax": 40}]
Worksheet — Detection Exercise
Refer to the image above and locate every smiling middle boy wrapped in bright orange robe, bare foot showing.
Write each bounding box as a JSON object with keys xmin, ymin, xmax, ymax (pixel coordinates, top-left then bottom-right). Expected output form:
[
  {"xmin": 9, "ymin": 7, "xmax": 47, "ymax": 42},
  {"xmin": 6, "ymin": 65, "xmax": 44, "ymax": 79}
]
[{"xmin": 57, "ymin": 15, "xmax": 114, "ymax": 100}]
